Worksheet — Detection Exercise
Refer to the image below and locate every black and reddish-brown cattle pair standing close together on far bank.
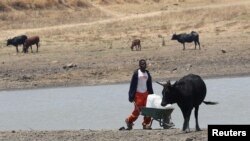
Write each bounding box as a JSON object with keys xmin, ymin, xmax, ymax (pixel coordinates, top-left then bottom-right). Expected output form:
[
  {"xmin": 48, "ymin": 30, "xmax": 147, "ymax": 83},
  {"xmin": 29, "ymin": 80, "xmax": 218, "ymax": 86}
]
[{"xmin": 7, "ymin": 35, "xmax": 40, "ymax": 53}]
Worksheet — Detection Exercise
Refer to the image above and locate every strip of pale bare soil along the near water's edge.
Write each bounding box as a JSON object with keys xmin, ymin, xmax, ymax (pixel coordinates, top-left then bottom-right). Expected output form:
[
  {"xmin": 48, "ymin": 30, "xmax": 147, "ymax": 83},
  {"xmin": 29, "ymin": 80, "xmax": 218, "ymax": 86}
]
[{"xmin": 0, "ymin": 129, "xmax": 207, "ymax": 141}]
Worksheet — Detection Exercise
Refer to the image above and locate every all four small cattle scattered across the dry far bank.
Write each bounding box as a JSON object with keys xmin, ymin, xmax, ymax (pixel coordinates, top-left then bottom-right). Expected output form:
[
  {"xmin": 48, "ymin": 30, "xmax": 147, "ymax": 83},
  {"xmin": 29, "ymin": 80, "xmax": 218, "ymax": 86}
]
[{"xmin": 7, "ymin": 31, "xmax": 201, "ymax": 53}]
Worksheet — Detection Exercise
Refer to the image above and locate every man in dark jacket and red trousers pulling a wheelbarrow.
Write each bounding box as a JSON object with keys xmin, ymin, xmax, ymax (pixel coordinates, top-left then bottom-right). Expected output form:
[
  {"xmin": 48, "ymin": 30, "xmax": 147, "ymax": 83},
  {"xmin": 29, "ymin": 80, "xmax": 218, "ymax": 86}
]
[{"xmin": 125, "ymin": 59, "xmax": 154, "ymax": 130}]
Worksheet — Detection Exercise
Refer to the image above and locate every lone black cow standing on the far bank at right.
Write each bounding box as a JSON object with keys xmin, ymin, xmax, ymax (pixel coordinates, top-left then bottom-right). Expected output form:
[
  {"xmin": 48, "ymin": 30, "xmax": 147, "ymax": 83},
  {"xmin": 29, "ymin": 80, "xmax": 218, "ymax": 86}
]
[{"xmin": 171, "ymin": 31, "xmax": 201, "ymax": 50}]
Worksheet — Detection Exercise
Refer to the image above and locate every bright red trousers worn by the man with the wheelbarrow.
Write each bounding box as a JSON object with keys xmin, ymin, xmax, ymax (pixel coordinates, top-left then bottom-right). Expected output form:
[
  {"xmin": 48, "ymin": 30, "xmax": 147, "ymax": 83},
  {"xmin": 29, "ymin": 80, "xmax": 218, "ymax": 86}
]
[{"xmin": 127, "ymin": 92, "xmax": 151, "ymax": 125}]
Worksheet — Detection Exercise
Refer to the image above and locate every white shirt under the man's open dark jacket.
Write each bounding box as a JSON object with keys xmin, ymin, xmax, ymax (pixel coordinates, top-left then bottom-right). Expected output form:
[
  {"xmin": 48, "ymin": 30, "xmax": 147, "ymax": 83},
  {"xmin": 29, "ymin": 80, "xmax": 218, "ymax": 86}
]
[{"xmin": 136, "ymin": 69, "xmax": 148, "ymax": 93}]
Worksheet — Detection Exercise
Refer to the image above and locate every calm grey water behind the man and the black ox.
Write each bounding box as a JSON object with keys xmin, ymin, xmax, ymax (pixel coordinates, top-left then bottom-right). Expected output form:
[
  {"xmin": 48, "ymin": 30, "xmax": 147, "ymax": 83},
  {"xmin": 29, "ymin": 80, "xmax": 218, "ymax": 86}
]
[{"xmin": 0, "ymin": 77, "xmax": 250, "ymax": 131}]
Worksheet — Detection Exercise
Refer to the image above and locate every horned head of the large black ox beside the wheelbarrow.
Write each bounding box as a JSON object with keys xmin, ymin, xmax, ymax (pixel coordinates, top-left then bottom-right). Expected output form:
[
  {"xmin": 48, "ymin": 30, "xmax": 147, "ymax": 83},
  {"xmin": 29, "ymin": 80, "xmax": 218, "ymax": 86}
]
[{"xmin": 156, "ymin": 81, "xmax": 174, "ymax": 106}]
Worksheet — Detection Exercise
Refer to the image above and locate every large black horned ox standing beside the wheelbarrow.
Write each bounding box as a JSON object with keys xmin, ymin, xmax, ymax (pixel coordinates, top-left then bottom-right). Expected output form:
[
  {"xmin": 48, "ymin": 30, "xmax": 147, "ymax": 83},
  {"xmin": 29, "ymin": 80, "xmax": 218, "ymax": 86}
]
[{"xmin": 157, "ymin": 74, "xmax": 217, "ymax": 132}]
